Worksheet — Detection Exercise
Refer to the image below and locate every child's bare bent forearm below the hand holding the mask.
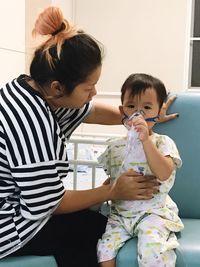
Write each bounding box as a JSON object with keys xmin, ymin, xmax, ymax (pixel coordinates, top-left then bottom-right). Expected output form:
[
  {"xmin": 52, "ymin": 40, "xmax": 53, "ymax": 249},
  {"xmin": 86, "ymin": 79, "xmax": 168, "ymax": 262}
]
[{"xmin": 143, "ymin": 137, "xmax": 175, "ymax": 181}]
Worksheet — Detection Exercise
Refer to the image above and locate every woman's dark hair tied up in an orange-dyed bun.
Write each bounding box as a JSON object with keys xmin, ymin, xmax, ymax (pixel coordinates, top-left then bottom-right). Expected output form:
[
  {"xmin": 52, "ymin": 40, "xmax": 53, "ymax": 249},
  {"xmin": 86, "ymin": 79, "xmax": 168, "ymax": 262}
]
[{"xmin": 30, "ymin": 6, "xmax": 103, "ymax": 95}]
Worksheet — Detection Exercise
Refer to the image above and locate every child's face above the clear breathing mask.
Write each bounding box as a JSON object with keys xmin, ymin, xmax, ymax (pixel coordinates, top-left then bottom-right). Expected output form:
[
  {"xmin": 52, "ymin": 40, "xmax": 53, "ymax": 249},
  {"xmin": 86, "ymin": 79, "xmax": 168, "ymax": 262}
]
[{"xmin": 123, "ymin": 88, "xmax": 159, "ymax": 126}]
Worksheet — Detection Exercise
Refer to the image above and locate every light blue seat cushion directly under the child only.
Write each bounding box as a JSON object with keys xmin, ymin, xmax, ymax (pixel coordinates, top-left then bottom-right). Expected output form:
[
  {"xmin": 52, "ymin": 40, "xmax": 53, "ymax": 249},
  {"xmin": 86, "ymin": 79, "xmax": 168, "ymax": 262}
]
[{"xmin": 117, "ymin": 219, "xmax": 200, "ymax": 267}]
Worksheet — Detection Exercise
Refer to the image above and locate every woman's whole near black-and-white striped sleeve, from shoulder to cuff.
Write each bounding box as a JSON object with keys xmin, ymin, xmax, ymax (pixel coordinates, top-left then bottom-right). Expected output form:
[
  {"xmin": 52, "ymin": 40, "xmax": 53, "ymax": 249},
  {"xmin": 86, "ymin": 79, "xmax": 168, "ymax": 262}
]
[{"xmin": 0, "ymin": 80, "xmax": 68, "ymax": 220}]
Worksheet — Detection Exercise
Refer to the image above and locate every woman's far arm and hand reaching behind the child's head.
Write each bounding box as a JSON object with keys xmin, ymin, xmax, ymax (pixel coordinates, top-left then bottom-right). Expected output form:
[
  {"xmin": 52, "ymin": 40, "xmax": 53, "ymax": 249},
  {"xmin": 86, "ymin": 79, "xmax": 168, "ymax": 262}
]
[{"xmin": 83, "ymin": 96, "xmax": 178, "ymax": 125}]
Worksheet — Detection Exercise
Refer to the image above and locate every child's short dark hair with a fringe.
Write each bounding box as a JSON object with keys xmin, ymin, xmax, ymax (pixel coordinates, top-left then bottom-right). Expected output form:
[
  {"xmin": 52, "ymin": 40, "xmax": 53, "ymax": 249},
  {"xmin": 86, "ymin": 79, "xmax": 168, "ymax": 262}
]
[{"xmin": 121, "ymin": 73, "xmax": 167, "ymax": 108}]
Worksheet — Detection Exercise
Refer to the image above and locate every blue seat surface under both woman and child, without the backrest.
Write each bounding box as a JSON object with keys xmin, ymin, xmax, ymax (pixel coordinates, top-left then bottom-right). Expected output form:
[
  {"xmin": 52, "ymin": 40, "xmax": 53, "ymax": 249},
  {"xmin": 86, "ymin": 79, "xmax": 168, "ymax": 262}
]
[{"xmin": 0, "ymin": 219, "xmax": 200, "ymax": 267}]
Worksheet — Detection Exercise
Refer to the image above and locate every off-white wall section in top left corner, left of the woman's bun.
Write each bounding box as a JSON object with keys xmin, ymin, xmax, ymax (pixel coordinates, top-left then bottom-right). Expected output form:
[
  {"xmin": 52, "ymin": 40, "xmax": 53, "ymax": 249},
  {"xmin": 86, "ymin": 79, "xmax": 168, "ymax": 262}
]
[{"xmin": 0, "ymin": 0, "xmax": 25, "ymax": 86}]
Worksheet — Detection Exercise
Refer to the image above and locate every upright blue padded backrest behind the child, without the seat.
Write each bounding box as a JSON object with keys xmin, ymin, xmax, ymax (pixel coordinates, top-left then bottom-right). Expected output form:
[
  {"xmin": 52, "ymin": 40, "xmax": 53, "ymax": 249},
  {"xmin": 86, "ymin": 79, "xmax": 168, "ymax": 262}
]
[{"xmin": 154, "ymin": 93, "xmax": 200, "ymax": 219}]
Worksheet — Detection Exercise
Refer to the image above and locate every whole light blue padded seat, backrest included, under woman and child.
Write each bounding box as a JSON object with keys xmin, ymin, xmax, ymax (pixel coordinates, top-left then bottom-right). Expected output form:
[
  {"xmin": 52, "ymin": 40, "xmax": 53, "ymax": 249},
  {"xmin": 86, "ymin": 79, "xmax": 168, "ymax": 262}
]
[{"xmin": 0, "ymin": 93, "xmax": 200, "ymax": 267}]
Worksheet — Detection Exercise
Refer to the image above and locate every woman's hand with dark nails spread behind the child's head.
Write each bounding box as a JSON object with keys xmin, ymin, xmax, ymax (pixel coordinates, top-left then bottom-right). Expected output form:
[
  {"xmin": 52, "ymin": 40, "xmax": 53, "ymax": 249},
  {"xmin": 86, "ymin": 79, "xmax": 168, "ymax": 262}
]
[{"xmin": 156, "ymin": 95, "xmax": 179, "ymax": 123}]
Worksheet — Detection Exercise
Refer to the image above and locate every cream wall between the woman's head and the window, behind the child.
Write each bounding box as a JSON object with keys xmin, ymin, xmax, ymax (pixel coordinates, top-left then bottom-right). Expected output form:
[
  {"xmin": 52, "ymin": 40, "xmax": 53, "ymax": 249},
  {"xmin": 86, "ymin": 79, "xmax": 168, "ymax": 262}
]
[{"xmin": 74, "ymin": 0, "xmax": 188, "ymax": 133}]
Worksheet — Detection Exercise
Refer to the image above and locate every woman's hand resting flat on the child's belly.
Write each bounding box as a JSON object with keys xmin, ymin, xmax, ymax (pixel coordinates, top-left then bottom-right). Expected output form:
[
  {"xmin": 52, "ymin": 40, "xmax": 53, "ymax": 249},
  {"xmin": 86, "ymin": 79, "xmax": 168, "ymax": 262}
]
[{"xmin": 110, "ymin": 170, "xmax": 160, "ymax": 200}]
